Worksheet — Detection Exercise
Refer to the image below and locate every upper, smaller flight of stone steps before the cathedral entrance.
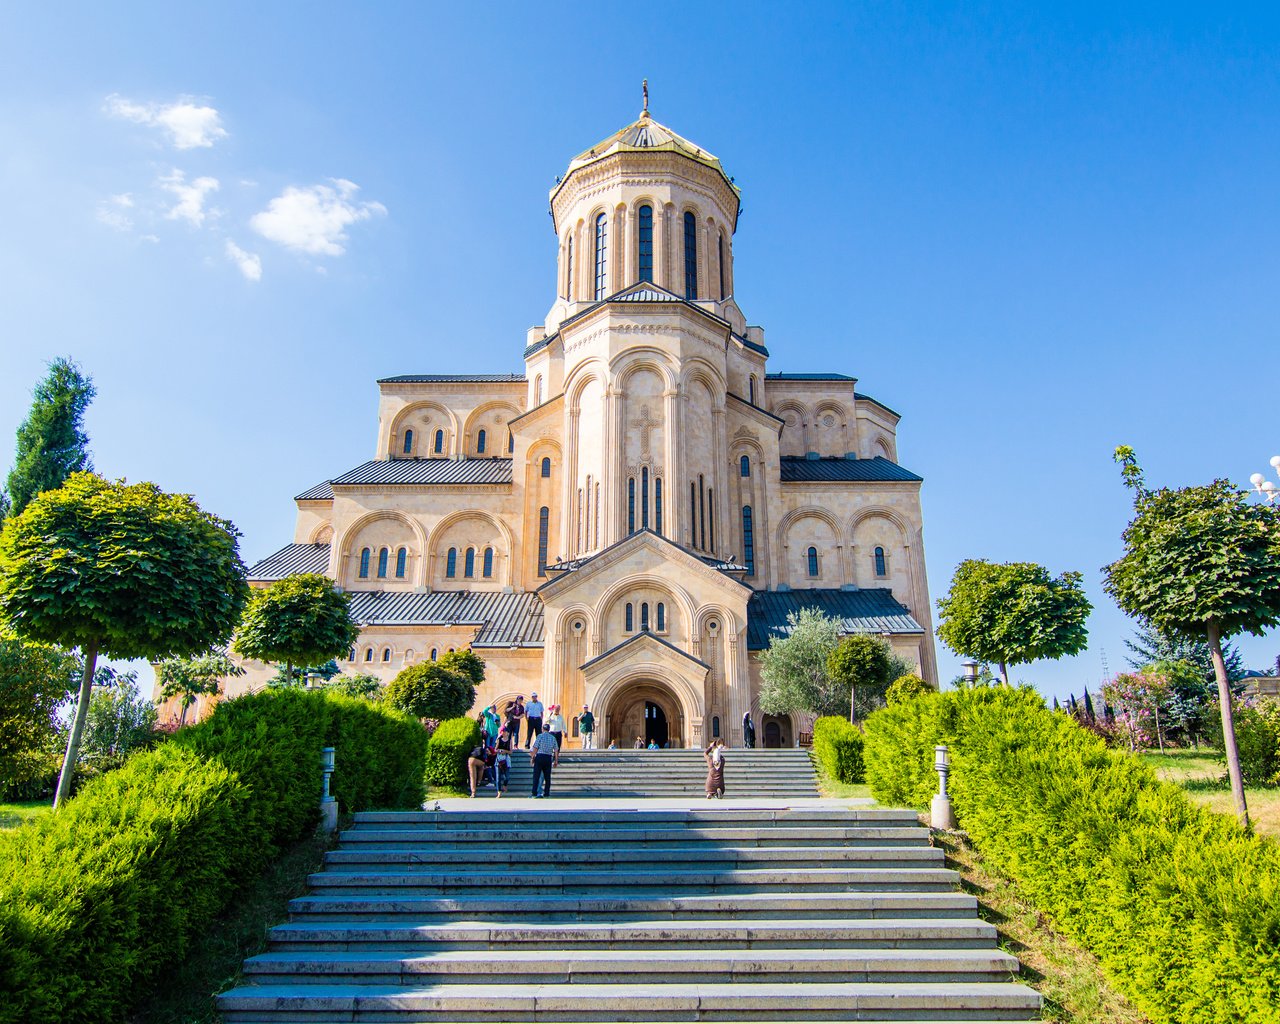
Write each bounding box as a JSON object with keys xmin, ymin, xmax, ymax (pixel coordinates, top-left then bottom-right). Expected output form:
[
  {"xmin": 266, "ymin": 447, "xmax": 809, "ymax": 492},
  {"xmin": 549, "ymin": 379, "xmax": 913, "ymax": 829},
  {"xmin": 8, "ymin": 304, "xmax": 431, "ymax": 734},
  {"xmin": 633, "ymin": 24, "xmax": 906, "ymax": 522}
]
[{"xmin": 499, "ymin": 748, "xmax": 818, "ymax": 800}]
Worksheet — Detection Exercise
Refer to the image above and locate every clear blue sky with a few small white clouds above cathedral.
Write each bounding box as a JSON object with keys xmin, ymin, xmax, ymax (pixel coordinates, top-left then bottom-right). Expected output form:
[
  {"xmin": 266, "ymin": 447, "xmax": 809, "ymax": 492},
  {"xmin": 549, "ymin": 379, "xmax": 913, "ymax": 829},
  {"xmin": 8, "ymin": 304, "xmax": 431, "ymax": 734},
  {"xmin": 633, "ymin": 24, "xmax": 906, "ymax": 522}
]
[{"xmin": 0, "ymin": 3, "xmax": 1280, "ymax": 695}]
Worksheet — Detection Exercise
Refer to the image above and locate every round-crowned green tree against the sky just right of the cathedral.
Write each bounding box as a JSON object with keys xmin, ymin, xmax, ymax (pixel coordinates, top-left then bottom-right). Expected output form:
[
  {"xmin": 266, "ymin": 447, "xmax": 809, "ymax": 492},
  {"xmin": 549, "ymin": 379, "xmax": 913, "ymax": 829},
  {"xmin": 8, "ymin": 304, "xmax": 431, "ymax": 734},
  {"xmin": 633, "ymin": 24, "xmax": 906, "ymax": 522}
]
[{"xmin": 938, "ymin": 558, "xmax": 1093, "ymax": 684}]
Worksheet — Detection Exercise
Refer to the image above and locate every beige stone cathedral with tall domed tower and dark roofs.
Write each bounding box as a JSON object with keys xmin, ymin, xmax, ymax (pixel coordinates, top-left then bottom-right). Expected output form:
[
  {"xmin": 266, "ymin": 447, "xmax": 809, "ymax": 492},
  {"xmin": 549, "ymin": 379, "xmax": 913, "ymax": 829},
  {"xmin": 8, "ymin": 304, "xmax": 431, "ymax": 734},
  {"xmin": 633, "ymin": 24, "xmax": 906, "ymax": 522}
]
[{"xmin": 235, "ymin": 101, "xmax": 937, "ymax": 746}]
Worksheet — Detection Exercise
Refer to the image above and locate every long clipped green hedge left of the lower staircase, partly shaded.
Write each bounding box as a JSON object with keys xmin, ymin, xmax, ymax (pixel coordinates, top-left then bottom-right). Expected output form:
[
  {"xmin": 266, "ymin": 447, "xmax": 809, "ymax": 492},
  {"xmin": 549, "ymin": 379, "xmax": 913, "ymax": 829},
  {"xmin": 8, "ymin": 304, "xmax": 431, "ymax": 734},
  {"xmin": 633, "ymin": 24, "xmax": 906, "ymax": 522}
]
[{"xmin": 0, "ymin": 690, "xmax": 426, "ymax": 1024}]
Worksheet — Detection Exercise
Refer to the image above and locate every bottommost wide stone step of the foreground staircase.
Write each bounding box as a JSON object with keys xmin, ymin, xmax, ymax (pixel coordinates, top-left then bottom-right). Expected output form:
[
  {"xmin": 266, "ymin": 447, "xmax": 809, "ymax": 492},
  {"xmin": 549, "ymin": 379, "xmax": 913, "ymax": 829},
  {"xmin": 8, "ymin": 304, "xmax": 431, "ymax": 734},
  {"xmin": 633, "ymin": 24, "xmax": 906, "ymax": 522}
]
[{"xmin": 218, "ymin": 982, "xmax": 1039, "ymax": 1024}]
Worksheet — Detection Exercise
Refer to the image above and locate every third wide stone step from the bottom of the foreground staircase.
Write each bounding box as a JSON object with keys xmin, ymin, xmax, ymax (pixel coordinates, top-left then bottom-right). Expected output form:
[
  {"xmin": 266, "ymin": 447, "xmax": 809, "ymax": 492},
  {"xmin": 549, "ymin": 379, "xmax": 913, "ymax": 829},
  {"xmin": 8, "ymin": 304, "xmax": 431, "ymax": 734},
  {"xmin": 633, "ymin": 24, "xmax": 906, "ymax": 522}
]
[{"xmin": 271, "ymin": 918, "xmax": 996, "ymax": 952}]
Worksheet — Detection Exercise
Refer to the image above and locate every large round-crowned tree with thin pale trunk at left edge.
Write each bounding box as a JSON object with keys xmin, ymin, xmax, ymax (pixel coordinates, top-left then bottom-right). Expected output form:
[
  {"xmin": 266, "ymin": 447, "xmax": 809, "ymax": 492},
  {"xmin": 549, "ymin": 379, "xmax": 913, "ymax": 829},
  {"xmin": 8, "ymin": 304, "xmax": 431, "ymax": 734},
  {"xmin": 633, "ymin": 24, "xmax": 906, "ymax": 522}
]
[{"xmin": 0, "ymin": 472, "xmax": 246, "ymax": 806}]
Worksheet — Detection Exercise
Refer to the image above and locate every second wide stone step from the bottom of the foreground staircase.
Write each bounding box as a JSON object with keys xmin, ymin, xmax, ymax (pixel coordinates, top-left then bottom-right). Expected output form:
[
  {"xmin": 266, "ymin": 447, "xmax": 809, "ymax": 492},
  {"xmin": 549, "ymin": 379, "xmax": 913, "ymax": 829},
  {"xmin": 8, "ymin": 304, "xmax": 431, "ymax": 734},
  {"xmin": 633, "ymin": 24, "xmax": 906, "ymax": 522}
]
[{"xmin": 244, "ymin": 947, "xmax": 1018, "ymax": 987}]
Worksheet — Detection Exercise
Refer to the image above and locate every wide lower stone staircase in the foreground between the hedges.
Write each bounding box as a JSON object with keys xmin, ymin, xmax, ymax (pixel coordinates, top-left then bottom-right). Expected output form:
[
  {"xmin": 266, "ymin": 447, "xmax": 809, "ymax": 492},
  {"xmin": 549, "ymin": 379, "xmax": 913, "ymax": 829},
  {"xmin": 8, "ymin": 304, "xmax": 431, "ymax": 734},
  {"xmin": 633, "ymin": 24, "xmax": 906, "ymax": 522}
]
[{"xmin": 219, "ymin": 801, "xmax": 1039, "ymax": 1024}]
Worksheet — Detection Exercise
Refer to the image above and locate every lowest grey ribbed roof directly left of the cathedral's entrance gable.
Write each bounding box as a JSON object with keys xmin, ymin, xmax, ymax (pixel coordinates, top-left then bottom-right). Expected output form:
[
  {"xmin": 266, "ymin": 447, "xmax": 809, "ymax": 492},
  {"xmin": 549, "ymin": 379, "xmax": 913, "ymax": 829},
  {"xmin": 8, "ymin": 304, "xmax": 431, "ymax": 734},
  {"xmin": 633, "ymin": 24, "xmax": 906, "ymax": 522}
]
[{"xmin": 351, "ymin": 590, "xmax": 543, "ymax": 648}]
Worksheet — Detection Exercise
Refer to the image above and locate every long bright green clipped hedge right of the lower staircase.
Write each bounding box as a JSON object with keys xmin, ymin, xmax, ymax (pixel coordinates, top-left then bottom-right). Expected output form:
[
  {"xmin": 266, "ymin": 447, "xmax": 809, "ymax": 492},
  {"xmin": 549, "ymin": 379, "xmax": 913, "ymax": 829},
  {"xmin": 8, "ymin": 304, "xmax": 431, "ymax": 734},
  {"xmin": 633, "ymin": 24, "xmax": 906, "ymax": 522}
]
[{"xmin": 865, "ymin": 687, "xmax": 1280, "ymax": 1024}]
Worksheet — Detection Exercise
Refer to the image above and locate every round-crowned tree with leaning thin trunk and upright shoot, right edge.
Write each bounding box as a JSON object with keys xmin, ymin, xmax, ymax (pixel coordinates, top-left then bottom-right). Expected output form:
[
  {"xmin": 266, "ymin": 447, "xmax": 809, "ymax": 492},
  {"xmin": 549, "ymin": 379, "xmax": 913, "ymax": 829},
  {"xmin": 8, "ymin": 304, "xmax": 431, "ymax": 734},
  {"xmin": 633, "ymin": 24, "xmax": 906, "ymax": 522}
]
[{"xmin": 1102, "ymin": 445, "xmax": 1280, "ymax": 826}]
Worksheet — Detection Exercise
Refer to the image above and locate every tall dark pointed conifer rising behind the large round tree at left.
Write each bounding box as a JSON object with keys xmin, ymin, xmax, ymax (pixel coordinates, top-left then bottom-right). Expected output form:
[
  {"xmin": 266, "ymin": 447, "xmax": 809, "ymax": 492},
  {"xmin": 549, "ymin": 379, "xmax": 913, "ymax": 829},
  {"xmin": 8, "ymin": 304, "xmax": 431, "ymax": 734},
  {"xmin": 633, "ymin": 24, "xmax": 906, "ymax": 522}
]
[{"xmin": 9, "ymin": 358, "xmax": 97, "ymax": 515}]
